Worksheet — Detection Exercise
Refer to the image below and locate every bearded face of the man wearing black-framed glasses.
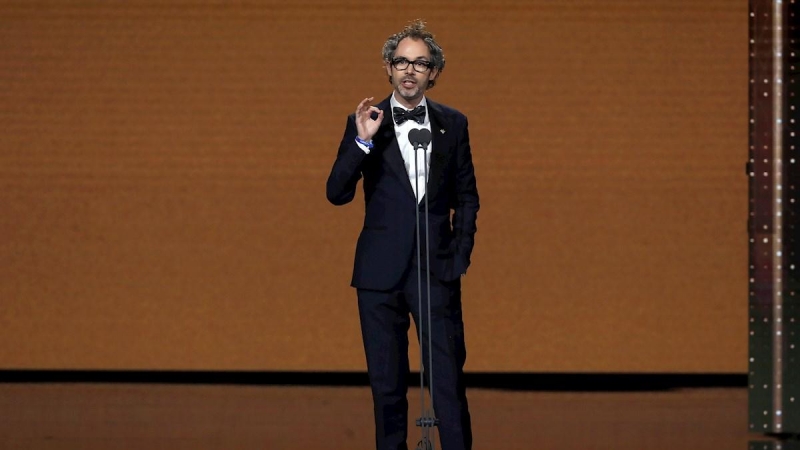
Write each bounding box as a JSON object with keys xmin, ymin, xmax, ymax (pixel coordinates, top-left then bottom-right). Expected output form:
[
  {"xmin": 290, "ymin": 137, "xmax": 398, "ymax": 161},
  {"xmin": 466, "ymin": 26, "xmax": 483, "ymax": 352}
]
[{"xmin": 386, "ymin": 38, "xmax": 439, "ymax": 109}]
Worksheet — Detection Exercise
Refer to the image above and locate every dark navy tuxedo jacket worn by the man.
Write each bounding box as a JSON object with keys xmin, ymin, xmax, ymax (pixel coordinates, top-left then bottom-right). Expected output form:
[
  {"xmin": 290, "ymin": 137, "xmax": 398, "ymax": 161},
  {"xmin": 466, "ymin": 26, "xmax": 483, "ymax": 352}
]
[{"xmin": 327, "ymin": 97, "xmax": 479, "ymax": 290}]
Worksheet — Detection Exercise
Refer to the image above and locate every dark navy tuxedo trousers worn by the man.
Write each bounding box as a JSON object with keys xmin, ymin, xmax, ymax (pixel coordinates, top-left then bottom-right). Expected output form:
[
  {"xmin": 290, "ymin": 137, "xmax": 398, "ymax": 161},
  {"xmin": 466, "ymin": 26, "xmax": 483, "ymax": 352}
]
[{"xmin": 357, "ymin": 255, "xmax": 472, "ymax": 450}]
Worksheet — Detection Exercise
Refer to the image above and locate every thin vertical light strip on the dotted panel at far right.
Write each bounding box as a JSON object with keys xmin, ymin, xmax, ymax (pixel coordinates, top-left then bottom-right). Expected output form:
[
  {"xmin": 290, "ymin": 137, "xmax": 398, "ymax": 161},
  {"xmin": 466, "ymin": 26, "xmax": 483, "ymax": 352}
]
[{"xmin": 772, "ymin": 0, "xmax": 783, "ymax": 433}]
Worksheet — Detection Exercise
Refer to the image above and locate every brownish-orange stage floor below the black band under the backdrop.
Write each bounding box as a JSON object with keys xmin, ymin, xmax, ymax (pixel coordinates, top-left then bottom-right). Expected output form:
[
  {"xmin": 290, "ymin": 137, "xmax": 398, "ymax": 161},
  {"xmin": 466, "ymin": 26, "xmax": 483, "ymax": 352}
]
[{"xmin": 0, "ymin": 383, "xmax": 772, "ymax": 450}]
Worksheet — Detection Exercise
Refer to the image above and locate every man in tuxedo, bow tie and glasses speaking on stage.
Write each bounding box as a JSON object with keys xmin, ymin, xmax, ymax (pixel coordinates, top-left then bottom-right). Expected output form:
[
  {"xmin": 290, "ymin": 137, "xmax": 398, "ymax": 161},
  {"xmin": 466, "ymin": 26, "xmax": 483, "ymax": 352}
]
[{"xmin": 327, "ymin": 21, "xmax": 479, "ymax": 450}]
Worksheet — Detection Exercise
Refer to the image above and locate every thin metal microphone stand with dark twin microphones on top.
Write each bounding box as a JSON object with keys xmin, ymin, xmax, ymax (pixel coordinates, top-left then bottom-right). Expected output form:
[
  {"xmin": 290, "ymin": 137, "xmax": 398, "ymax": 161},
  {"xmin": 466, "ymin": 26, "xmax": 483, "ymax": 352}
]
[{"xmin": 408, "ymin": 128, "xmax": 439, "ymax": 450}]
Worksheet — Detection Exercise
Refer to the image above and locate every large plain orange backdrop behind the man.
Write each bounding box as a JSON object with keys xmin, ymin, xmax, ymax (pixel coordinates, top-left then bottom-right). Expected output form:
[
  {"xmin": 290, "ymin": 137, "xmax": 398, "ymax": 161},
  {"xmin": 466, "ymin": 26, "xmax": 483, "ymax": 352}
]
[{"xmin": 0, "ymin": 0, "xmax": 748, "ymax": 373}]
